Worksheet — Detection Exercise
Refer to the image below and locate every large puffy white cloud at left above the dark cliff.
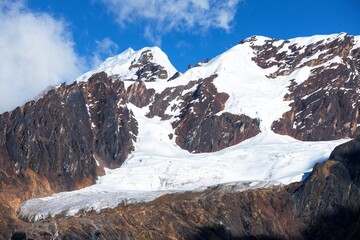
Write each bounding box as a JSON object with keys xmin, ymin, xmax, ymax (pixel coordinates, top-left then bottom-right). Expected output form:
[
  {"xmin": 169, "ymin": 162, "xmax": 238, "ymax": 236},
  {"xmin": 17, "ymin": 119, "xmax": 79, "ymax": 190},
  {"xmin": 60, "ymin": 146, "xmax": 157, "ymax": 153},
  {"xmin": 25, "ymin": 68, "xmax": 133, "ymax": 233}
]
[{"xmin": 0, "ymin": 0, "xmax": 80, "ymax": 113}]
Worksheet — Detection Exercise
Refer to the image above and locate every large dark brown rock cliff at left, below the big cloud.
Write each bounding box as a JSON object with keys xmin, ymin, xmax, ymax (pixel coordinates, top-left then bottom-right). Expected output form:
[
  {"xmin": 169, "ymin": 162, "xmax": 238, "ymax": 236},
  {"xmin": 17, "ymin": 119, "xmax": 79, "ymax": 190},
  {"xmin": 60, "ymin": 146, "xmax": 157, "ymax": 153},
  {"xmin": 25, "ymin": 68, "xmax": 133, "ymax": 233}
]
[{"xmin": 0, "ymin": 73, "xmax": 137, "ymax": 195}]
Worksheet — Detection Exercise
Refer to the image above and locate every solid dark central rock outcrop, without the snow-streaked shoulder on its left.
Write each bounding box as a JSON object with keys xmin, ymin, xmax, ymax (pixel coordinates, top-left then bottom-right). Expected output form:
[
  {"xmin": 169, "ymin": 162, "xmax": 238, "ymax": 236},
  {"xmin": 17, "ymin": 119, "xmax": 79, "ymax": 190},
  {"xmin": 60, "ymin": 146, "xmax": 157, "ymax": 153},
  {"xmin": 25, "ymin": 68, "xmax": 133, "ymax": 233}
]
[{"xmin": 173, "ymin": 76, "xmax": 260, "ymax": 152}]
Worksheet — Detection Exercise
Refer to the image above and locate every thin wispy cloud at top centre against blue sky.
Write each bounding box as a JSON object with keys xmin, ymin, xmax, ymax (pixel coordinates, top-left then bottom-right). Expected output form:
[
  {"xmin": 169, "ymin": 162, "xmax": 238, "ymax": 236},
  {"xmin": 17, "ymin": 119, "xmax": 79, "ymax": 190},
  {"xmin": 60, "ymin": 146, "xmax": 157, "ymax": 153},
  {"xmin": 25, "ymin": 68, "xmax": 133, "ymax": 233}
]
[{"xmin": 100, "ymin": 0, "xmax": 241, "ymax": 43}]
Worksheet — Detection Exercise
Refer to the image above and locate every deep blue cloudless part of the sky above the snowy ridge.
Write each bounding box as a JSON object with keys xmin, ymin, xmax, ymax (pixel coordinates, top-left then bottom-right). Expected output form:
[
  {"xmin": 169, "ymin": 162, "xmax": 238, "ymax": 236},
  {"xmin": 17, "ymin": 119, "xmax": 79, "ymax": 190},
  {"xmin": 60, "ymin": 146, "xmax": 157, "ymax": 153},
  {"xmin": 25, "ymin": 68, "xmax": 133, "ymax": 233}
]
[{"xmin": 28, "ymin": 0, "xmax": 360, "ymax": 71}]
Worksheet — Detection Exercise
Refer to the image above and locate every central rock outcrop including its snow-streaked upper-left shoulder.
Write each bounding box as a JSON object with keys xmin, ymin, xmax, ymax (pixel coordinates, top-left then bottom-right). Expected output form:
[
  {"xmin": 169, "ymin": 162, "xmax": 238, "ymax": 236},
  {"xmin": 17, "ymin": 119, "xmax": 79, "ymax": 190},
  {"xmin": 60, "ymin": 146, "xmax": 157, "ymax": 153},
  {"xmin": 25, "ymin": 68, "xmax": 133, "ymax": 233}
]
[{"xmin": 148, "ymin": 75, "xmax": 260, "ymax": 153}]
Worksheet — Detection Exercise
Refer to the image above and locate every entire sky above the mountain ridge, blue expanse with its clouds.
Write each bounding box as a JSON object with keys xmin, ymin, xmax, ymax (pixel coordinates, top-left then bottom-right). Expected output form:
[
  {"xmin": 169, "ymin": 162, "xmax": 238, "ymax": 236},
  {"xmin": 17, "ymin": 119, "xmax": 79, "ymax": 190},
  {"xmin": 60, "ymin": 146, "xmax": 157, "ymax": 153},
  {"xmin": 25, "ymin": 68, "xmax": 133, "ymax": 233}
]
[{"xmin": 0, "ymin": 0, "xmax": 360, "ymax": 112}]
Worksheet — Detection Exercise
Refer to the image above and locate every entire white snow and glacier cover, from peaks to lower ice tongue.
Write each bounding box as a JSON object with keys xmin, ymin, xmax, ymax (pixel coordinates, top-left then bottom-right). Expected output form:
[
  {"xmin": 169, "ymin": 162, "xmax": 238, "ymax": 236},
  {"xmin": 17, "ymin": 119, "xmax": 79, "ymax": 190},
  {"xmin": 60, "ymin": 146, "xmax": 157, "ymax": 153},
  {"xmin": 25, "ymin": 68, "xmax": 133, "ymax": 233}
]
[{"xmin": 20, "ymin": 34, "xmax": 359, "ymax": 219}]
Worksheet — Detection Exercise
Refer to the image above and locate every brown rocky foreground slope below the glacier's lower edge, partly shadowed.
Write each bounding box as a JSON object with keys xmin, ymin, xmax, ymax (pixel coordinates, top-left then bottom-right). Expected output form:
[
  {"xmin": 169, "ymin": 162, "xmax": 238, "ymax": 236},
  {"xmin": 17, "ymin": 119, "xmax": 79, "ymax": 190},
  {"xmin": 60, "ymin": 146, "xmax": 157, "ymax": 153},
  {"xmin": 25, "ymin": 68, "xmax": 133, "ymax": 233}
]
[{"xmin": 18, "ymin": 136, "xmax": 360, "ymax": 239}]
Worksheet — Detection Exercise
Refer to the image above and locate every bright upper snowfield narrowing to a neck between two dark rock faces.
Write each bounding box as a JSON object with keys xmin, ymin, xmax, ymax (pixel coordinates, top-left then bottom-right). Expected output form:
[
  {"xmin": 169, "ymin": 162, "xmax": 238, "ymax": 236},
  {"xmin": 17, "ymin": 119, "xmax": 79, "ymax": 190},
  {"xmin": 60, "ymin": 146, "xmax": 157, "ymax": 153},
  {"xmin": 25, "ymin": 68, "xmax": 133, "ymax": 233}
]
[{"xmin": 181, "ymin": 37, "xmax": 289, "ymax": 131}]
